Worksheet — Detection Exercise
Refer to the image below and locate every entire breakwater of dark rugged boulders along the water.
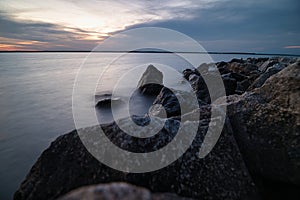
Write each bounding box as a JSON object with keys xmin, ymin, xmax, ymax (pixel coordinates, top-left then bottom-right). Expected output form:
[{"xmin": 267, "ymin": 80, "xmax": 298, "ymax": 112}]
[{"xmin": 14, "ymin": 58, "xmax": 300, "ymax": 199}]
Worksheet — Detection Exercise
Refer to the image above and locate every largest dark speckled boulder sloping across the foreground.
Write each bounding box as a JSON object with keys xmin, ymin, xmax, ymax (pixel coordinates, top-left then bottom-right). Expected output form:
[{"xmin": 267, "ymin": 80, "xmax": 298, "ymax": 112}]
[{"xmin": 14, "ymin": 116, "xmax": 258, "ymax": 200}]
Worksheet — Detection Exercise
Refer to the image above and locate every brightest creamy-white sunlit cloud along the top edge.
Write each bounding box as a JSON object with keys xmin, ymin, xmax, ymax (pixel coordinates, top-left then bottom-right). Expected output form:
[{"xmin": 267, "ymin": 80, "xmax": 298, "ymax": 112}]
[{"xmin": 0, "ymin": 0, "xmax": 219, "ymax": 35}]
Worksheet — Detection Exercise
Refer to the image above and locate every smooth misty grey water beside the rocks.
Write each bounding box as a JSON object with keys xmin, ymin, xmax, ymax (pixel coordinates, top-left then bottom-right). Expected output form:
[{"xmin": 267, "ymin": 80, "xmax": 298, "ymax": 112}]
[{"xmin": 0, "ymin": 53, "xmax": 268, "ymax": 199}]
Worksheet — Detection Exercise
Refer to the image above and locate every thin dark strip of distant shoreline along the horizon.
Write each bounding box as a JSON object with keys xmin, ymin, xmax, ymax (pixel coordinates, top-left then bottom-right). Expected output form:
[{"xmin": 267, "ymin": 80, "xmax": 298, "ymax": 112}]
[{"xmin": 0, "ymin": 50, "xmax": 300, "ymax": 57}]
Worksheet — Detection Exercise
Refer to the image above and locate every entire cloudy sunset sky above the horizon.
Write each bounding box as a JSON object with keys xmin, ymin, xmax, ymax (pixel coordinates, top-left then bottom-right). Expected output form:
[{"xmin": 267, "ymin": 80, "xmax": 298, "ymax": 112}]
[{"xmin": 0, "ymin": 0, "xmax": 300, "ymax": 54}]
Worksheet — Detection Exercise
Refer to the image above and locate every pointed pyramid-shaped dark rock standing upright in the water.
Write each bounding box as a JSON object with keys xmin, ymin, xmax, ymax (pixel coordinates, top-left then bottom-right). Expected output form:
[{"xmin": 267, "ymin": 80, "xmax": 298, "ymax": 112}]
[{"xmin": 137, "ymin": 65, "xmax": 163, "ymax": 96}]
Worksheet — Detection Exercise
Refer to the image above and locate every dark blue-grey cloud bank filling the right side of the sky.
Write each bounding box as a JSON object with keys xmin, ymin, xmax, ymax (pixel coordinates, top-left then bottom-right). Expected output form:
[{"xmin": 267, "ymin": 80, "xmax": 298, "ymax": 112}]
[{"xmin": 126, "ymin": 0, "xmax": 300, "ymax": 53}]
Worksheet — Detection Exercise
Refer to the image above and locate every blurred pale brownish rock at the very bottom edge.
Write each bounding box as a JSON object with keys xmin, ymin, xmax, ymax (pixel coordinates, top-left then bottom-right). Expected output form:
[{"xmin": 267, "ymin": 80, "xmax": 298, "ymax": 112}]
[{"xmin": 58, "ymin": 183, "xmax": 189, "ymax": 200}]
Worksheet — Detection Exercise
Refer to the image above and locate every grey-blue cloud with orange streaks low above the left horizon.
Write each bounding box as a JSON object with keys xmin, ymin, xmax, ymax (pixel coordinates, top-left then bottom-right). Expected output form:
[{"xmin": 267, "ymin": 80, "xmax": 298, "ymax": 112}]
[{"xmin": 0, "ymin": 14, "xmax": 103, "ymax": 50}]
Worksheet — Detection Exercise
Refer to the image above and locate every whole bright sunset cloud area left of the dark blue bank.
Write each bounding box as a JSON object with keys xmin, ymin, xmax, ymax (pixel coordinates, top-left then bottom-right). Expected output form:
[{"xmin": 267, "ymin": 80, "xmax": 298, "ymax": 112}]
[{"xmin": 0, "ymin": 0, "xmax": 225, "ymax": 50}]
